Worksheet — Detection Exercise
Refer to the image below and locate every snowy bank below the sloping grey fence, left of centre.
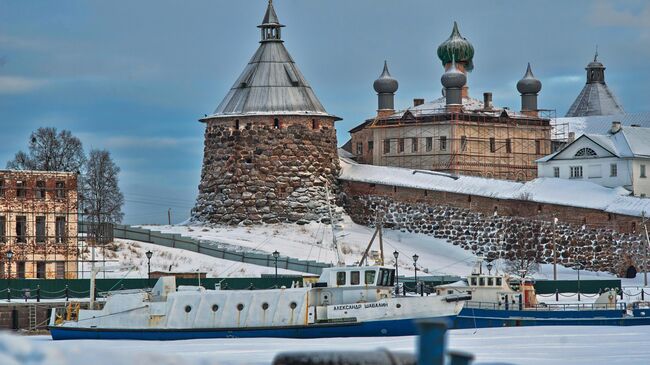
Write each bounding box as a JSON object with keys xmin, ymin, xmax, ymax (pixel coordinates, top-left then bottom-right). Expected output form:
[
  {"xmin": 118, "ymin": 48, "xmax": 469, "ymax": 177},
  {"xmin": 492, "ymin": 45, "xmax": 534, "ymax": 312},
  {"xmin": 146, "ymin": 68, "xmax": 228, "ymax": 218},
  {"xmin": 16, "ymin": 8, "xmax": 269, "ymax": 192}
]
[{"xmin": 81, "ymin": 239, "xmax": 302, "ymax": 278}]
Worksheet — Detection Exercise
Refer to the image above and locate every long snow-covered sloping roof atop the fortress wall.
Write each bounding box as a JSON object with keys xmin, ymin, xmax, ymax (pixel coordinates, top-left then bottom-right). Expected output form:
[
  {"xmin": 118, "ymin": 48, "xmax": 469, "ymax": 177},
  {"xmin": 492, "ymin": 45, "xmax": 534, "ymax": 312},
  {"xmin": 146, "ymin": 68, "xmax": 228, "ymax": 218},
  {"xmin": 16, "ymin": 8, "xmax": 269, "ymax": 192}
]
[{"xmin": 339, "ymin": 158, "xmax": 650, "ymax": 216}]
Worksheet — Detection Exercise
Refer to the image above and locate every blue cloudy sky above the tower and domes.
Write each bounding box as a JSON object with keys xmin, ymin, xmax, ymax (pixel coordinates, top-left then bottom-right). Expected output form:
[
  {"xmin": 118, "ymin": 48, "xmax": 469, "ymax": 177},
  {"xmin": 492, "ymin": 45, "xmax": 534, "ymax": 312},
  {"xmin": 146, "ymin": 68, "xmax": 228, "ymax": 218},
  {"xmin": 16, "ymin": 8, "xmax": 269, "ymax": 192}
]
[{"xmin": 0, "ymin": 0, "xmax": 650, "ymax": 224}]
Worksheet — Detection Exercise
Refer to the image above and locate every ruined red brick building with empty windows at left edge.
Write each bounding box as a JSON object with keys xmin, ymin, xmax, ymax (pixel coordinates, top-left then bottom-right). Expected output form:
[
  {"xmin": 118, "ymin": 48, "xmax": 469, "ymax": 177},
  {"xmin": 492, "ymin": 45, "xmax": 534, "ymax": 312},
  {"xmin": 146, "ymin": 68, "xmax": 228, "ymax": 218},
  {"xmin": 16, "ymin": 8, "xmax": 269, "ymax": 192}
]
[{"xmin": 0, "ymin": 170, "xmax": 78, "ymax": 279}]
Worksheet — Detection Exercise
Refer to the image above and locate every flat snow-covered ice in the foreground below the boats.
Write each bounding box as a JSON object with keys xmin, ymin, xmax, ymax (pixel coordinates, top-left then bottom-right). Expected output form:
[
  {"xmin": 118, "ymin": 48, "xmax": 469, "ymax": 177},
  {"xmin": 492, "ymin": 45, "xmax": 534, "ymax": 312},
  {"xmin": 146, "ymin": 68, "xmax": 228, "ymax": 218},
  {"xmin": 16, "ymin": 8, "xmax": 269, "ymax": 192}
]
[{"xmin": 10, "ymin": 326, "xmax": 650, "ymax": 365}]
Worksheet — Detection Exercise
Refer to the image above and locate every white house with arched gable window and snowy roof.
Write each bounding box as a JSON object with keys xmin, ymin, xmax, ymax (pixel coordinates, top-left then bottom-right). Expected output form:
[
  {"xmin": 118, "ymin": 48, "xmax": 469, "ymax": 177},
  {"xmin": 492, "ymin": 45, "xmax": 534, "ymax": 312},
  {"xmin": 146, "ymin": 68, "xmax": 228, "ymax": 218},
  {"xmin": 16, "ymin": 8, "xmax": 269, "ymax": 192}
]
[{"xmin": 537, "ymin": 122, "xmax": 650, "ymax": 197}]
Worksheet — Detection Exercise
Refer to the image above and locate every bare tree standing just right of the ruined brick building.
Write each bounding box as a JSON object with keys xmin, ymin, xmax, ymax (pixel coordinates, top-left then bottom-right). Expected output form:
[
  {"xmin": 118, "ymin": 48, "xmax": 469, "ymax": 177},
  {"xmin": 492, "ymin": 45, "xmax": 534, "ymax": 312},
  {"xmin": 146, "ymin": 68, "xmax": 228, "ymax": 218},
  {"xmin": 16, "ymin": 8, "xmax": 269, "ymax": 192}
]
[{"xmin": 81, "ymin": 149, "xmax": 124, "ymax": 226}]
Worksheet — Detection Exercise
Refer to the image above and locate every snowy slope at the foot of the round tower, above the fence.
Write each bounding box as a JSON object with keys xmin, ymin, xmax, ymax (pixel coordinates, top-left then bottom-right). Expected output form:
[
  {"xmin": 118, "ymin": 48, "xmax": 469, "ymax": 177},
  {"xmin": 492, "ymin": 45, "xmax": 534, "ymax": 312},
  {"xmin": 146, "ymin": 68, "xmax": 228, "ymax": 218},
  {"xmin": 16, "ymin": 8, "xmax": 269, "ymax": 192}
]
[{"xmin": 143, "ymin": 214, "xmax": 613, "ymax": 279}]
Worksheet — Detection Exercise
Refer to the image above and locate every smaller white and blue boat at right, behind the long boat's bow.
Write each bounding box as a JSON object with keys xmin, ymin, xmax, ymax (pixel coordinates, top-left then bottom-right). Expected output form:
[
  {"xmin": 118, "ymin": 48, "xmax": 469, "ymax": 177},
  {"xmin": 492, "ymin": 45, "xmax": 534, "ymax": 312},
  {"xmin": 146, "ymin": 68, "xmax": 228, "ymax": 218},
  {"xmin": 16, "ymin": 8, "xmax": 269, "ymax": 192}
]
[{"xmin": 435, "ymin": 259, "xmax": 650, "ymax": 329}]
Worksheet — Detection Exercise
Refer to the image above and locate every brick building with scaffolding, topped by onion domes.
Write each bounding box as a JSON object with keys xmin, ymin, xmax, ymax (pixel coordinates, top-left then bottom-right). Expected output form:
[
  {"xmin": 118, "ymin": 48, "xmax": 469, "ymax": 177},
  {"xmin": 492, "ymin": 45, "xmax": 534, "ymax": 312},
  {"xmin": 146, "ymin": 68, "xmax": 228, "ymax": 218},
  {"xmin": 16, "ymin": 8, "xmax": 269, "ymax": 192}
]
[{"xmin": 349, "ymin": 23, "xmax": 566, "ymax": 181}]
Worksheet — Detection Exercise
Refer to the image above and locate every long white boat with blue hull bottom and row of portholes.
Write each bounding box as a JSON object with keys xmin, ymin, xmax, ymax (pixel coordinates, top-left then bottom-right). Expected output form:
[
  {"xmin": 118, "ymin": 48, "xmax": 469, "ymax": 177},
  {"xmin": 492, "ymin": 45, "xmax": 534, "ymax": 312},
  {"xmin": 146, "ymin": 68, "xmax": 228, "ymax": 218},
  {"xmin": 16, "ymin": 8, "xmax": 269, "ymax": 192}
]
[{"xmin": 49, "ymin": 266, "xmax": 463, "ymax": 340}]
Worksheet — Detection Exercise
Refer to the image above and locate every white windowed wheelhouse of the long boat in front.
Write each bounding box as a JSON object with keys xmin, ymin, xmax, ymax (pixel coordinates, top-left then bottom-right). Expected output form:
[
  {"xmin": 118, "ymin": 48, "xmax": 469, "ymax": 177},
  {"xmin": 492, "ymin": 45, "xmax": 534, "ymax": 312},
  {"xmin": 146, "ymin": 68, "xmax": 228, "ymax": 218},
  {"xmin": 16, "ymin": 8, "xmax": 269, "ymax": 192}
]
[{"xmin": 314, "ymin": 266, "xmax": 395, "ymax": 288}]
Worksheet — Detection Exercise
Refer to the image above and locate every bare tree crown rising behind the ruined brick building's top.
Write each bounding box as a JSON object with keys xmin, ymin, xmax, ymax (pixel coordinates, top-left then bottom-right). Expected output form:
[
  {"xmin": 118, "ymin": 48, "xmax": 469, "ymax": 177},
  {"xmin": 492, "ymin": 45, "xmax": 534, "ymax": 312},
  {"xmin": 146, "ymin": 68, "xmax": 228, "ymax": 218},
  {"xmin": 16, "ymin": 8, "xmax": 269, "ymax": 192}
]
[{"xmin": 7, "ymin": 127, "xmax": 86, "ymax": 172}]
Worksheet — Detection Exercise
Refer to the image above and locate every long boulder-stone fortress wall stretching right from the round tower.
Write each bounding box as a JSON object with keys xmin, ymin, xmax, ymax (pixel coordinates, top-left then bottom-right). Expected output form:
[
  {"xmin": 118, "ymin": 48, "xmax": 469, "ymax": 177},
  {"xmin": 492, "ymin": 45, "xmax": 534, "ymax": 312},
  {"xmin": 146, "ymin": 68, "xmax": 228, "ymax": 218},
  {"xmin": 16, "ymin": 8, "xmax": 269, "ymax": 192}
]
[{"xmin": 342, "ymin": 182, "xmax": 644, "ymax": 275}]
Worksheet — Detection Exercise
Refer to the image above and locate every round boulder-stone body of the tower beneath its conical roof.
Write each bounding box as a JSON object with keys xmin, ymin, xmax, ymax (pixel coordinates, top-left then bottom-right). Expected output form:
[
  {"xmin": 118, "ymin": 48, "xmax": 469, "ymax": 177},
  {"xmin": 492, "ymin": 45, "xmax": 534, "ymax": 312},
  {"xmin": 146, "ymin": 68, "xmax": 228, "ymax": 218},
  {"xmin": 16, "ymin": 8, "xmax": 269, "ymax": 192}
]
[{"xmin": 193, "ymin": 116, "xmax": 339, "ymax": 225}]
